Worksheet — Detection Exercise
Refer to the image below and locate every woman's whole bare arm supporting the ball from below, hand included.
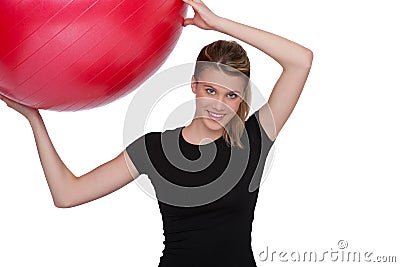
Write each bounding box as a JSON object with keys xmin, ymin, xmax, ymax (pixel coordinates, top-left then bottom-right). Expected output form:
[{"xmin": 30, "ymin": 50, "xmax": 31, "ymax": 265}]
[{"xmin": 0, "ymin": 96, "xmax": 139, "ymax": 208}]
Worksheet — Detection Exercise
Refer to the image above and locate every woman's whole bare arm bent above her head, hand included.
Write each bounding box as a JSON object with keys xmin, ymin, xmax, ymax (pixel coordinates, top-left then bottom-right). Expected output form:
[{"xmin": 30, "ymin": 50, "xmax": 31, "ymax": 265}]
[{"xmin": 184, "ymin": 0, "xmax": 313, "ymax": 140}]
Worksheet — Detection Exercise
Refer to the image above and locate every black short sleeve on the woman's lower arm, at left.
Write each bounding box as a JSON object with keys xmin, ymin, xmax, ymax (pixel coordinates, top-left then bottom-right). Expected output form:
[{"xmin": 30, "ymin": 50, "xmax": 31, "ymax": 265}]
[{"xmin": 126, "ymin": 135, "xmax": 147, "ymax": 174}]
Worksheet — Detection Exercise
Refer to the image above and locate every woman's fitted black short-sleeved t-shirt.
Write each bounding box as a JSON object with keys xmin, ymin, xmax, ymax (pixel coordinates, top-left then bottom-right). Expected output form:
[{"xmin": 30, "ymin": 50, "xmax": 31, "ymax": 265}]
[{"xmin": 126, "ymin": 110, "xmax": 274, "ymax": 267}]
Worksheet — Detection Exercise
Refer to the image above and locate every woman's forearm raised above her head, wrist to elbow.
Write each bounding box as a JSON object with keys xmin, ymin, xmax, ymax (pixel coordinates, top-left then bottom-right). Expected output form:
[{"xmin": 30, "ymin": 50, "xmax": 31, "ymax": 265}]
[{"xmin": 213, "ymin": 17, "xmax": 312, "ymax": 70}]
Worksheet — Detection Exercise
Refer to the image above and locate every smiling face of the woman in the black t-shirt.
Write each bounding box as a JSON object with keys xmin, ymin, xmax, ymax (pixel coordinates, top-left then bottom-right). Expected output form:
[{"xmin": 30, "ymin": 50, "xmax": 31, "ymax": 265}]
[{"xmin": 192, "ymin": 68, "xmax": 246, "ymax": 130}]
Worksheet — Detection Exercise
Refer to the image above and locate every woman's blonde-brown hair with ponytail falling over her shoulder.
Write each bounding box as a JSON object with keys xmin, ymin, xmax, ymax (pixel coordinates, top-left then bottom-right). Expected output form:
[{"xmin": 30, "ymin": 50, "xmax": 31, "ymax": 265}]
[{"xmin": 194, "ymin": 40, "xmax": 251, "ymax": 148}]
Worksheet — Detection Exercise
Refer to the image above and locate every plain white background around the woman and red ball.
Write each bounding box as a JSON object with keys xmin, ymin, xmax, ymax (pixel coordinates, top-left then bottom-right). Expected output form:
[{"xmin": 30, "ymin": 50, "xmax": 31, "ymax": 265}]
[{"xmin": 0, "ymin": 0, "xmax": 400, "ymax": 267}]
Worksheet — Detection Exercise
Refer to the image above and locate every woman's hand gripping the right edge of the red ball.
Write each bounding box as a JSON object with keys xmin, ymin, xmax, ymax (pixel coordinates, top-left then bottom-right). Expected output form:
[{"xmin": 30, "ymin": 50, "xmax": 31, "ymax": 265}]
[{"xmin": 182, "ymin": 0, "xmax": 221, "ymax": 30}]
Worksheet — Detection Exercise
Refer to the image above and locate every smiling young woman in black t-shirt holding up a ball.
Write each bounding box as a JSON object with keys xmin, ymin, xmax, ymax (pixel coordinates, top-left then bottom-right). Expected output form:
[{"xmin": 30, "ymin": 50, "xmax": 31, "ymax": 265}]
[{"xmin": 0, "ymin": 0, "xmax": 313, "ymax": 267}]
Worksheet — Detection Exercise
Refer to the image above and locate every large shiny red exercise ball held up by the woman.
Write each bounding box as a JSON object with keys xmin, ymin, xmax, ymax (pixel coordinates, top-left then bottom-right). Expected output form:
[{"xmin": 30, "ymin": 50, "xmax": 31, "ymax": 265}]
[{"xmin": 0, "ymin": 0, "xmax": 187, "ymax": 111}]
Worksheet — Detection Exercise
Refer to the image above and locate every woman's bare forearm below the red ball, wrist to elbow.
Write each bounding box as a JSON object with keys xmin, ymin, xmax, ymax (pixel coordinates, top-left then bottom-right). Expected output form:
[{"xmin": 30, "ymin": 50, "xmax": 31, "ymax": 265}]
[{"xmin": 29, "ymin": 112, "xmax": 76, "ymax": 207}]
